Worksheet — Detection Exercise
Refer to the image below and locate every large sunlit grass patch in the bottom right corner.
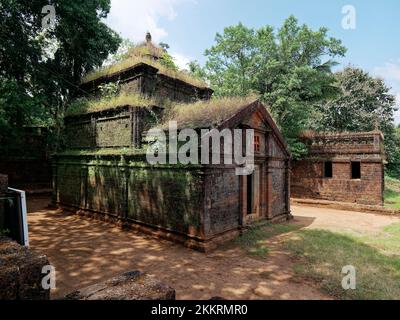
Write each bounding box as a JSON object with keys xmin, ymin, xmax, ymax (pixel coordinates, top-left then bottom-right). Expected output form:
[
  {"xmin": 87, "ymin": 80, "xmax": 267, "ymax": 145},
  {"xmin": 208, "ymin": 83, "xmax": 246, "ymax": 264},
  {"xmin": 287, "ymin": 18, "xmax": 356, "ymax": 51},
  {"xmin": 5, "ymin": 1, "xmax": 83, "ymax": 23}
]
[{"xmin": 285, "ymin": 224, "xmax": 400, "ymax": 299}]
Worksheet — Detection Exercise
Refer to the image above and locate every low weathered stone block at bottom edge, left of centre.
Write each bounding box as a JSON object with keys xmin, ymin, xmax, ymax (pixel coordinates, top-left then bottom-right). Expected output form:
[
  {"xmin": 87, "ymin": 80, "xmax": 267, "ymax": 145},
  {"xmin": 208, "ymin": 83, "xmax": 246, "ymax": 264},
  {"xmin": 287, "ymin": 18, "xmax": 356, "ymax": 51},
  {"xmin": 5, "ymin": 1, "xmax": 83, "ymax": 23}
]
[{"xmin": 65, "ymin": 271, "xmax": 175, "ymax": 300}]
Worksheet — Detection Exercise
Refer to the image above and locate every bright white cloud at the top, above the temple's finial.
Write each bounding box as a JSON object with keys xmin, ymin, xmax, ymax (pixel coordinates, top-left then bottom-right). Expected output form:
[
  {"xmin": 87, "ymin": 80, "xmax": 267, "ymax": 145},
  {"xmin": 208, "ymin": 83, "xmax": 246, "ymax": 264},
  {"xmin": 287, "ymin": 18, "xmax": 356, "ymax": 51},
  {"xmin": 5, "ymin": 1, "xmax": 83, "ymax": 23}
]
[{"xmin": 106, "ymin": 0, "xmax": 192, "ymax": 43}]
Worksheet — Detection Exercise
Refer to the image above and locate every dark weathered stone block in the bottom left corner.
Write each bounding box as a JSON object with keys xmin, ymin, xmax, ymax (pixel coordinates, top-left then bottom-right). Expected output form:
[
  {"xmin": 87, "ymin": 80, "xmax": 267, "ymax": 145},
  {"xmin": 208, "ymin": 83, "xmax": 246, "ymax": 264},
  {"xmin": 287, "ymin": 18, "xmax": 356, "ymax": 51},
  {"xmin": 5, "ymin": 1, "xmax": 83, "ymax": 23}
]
[{"xmin": 0, "ymin": 237, "xmax": 50, "ymax": 300}]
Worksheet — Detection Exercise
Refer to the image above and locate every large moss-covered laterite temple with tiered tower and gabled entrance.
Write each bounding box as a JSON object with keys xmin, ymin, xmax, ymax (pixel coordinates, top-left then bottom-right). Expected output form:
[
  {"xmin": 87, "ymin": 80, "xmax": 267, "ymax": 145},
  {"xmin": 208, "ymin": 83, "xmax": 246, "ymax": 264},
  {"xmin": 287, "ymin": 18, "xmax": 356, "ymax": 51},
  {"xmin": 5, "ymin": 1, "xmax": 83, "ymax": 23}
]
[{"xmin": 53, "ymin": 35, "xmax": 291, "ymax": 251}]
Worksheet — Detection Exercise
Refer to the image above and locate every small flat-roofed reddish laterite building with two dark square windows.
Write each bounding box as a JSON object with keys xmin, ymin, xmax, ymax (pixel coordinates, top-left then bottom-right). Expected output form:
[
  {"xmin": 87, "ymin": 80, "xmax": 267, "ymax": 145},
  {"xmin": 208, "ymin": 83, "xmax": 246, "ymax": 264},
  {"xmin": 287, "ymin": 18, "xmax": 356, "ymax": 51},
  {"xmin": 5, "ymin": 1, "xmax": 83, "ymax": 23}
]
[{"xmin": 291, "ymin": 131, "xmax": 384, "ymax": 205}]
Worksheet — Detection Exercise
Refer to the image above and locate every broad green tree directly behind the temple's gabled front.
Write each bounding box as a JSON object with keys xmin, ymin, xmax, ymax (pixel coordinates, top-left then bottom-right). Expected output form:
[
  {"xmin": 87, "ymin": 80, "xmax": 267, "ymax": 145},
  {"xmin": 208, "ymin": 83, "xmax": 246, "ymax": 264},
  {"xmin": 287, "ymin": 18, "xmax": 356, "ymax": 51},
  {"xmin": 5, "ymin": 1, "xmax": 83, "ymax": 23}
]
[{"xmin": 194, "ymin": 16, "xmax": 346, "ymax": 158}]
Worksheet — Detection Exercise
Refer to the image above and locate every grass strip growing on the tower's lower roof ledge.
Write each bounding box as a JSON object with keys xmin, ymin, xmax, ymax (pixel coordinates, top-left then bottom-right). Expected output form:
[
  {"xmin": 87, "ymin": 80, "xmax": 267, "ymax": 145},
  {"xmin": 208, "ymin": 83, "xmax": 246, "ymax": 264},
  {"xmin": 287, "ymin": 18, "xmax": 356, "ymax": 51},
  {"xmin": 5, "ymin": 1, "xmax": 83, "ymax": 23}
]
[{"xmin": 66, "ymin": 92, "xmax": 156, "ymax": 116}]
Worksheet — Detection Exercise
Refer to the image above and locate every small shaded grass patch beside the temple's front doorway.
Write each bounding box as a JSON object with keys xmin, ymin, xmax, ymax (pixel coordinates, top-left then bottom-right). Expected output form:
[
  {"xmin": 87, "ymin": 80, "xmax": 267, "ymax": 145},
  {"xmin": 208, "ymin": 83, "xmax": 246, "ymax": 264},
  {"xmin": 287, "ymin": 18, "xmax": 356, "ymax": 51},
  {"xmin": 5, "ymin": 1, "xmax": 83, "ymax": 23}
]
[{"xmin": 236, "ymin": 221, "xmax": 299, "ymax": 258}]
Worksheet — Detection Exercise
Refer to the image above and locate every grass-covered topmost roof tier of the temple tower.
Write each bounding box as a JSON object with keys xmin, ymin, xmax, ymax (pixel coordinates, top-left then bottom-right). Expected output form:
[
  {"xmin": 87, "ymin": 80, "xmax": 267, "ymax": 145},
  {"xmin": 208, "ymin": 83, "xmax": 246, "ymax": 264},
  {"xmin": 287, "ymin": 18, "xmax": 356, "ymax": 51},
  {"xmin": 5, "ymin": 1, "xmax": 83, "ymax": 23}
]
[{"xmin": 82, "ymin": 43, "xmax": 208, "ymax": 88}]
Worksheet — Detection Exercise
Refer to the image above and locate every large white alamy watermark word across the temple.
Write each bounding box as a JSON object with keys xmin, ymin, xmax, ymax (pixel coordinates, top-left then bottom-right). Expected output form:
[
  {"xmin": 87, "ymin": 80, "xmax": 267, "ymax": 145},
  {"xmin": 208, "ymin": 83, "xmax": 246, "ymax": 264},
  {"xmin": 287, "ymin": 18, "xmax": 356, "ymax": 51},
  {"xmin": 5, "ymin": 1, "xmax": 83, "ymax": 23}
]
[{"xmin": 146, "ymin": 121, "xmax": 254, "ymax": 175}]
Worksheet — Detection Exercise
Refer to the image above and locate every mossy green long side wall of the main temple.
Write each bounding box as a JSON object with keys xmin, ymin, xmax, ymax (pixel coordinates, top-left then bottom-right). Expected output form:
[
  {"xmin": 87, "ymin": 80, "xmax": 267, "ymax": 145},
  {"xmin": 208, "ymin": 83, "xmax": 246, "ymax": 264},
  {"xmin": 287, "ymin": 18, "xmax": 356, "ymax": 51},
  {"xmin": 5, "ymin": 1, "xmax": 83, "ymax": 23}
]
[{"xmin": 54, "ymin": 156, "xmax": 203, "ymax": 237}]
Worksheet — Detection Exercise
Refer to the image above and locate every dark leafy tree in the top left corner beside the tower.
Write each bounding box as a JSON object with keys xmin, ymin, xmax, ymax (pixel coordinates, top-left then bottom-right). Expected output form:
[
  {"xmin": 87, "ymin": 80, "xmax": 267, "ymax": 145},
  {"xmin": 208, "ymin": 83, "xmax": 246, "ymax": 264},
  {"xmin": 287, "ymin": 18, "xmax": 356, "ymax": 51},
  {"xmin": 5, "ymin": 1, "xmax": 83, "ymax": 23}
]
[{"xmin": 0, "ymin": 0, "xmax": 120, "ymax": 152}]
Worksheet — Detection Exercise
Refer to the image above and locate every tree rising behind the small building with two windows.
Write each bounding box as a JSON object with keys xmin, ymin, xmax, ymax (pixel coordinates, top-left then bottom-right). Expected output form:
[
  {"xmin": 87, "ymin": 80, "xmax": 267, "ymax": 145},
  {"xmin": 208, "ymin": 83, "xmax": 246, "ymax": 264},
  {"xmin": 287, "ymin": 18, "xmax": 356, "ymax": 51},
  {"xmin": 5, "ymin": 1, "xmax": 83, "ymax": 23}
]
[{"xmin": 314, "ymin": 67, "xmax": 400, "ymax": 178}]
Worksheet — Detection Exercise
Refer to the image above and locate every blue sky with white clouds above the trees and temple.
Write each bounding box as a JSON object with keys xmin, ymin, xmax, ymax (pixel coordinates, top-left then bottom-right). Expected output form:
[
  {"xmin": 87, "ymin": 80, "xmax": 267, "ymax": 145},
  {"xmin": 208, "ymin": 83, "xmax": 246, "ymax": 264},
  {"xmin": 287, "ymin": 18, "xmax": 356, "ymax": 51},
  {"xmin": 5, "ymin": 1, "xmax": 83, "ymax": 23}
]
[{"xmin": 106, "ymin": 0, "xmax": 400, "ymax": 123}]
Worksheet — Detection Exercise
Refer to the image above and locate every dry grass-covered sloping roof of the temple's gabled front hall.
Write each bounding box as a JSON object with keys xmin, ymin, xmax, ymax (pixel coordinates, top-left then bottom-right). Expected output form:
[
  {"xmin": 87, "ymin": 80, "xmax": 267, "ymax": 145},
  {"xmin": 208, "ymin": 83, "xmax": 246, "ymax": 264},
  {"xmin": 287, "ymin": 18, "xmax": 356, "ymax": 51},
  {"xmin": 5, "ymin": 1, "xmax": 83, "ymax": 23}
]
[{"xmin": 159, "ymin": 96, "xmax": 257, "ymax": 129}]
